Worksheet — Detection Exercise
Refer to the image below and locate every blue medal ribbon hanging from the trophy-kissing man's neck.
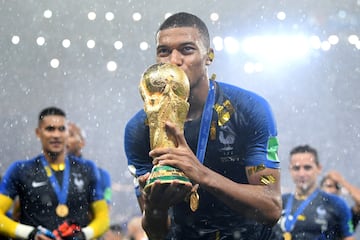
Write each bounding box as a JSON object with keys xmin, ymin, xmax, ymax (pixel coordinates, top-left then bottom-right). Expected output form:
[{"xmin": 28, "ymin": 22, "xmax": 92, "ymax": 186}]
[{"xmin": 196, "ymin": 80, "xmax": 215, "ymax": 164}]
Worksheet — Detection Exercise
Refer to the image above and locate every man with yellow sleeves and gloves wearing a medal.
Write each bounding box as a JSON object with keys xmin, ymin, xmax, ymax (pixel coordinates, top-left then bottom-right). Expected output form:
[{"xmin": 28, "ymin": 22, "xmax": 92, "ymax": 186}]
[{"xmin": 0, "ymin": 107, "xmax": 110, "ymax": 240}]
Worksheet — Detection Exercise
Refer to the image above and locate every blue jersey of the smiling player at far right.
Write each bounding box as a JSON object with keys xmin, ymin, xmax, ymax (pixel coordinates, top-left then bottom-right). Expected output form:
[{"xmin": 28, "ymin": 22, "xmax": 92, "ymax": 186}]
[{"xmin": 272, "ymin": 191, "xmax": 354, "ymax": 240}]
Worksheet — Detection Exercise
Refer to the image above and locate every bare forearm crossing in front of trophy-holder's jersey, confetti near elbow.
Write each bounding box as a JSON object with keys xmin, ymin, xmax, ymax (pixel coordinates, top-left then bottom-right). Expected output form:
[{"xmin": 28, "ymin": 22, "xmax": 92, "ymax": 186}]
[{"xmin": 200, "ymin": 167, "xmax": 282, "ymax": 225}]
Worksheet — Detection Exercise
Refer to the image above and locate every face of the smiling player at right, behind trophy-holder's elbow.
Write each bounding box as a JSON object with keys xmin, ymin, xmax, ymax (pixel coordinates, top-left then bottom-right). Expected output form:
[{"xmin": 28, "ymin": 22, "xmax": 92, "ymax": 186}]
[{"xmin": 290, "ymin": 153, "xmax": 321, "ymax": 192}]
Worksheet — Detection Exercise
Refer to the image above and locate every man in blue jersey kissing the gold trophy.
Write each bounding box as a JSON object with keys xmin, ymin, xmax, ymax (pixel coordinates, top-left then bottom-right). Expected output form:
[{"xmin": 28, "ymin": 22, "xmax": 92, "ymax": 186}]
[{"xmin": 124, "ymin": 12, "xmax": 282, "ymax": 240}]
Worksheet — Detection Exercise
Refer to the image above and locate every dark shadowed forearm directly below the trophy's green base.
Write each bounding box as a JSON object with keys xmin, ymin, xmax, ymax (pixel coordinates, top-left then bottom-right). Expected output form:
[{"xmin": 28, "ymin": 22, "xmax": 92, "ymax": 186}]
[{"xmin": 142, "ymin": 206, "xmax": 170, "ymax": 240}]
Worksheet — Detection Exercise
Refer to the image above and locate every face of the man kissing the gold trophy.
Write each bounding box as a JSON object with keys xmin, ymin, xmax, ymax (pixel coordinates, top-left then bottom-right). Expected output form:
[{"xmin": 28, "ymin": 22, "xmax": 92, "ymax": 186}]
[{"xmin": 156, "ymin": 27, "xmax": 210, "ymax": 87}]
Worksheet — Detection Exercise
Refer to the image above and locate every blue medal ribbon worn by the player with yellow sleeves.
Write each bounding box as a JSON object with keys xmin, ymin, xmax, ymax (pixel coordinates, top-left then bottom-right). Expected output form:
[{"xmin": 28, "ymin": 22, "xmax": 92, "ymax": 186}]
[{"xmin": 40, "ymin": 155, "xmax": 70, "ymax": 204}]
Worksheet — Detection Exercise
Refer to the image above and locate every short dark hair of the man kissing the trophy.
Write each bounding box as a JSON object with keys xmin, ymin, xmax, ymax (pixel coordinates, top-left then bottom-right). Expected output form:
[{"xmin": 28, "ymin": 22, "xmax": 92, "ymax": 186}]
[{"xmin": 157, "ymin": 12, "xmax": 210, "ymax": 48}]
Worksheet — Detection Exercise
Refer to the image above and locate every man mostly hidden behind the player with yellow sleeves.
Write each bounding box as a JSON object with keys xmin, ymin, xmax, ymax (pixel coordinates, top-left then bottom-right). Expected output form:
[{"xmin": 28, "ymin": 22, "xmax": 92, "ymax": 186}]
[{"xmin": 66, "ymin": 122, "xmax": 112, "ymax": 207}]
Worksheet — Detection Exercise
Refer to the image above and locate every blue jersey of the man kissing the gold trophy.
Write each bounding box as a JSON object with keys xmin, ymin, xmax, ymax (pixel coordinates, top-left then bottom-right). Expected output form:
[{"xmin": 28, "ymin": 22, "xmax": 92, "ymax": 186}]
[{"xmin": 124, "ymin": 82, "xmax": 279, "ymax": 240}]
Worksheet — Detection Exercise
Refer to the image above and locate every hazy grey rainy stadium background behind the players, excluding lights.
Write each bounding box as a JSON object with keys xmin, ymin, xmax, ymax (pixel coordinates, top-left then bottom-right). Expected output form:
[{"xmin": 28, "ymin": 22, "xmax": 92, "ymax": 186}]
[{"xmin": 0, "ymin": 0, "xmax": 360, "ymax": 235}]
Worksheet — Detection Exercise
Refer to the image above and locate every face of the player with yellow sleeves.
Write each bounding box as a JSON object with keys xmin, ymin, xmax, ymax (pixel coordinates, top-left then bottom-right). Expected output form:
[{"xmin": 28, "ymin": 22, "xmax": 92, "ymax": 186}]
[{"xmin": 36, "ymin": 115, "xmax": 68, "ymax": 154}]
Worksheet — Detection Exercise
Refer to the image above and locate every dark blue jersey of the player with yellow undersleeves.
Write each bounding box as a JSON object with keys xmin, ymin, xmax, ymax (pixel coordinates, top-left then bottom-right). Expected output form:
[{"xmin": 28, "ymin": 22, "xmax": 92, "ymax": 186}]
[{"xmin": 0, "ymin": 155, "xmax": 103, "ymax": 230}]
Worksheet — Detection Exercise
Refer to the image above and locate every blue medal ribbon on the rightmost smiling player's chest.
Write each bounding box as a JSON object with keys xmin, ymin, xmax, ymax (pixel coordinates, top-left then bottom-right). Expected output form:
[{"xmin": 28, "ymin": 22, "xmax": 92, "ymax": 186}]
[{"xmin": 285, "ymin": 189, "xmax": 319, "ymax": 232}]
